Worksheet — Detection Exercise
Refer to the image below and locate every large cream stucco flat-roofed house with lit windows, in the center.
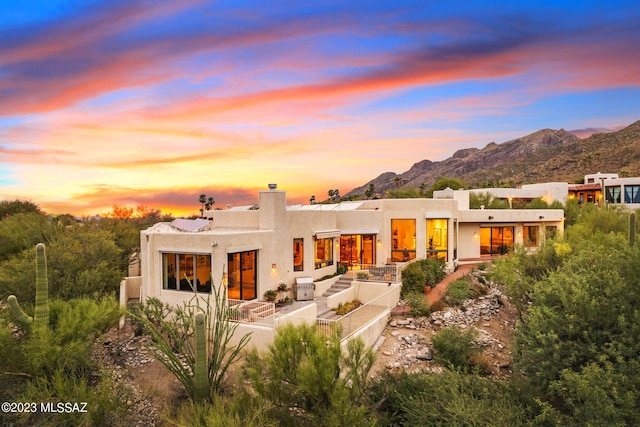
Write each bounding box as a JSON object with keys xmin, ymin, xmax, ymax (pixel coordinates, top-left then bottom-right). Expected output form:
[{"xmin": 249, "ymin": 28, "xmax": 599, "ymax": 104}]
[{"xmin": 121, "ymin": 185, "xmax": 566, "ymax": 347}]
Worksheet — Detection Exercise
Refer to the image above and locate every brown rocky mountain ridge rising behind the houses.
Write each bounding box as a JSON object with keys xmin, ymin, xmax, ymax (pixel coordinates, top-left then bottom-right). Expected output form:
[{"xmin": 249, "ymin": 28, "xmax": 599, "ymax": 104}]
[{"xmin": 346, "ymin": 121, "xmax": 640, "ymax": 196}]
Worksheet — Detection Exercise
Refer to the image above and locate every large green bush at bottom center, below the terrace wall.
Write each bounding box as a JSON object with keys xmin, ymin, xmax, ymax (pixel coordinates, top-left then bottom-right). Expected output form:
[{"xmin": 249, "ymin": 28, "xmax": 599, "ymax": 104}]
[{"xmin": 244, "ymin": 324, "xmax": 375, "ymax": 426}]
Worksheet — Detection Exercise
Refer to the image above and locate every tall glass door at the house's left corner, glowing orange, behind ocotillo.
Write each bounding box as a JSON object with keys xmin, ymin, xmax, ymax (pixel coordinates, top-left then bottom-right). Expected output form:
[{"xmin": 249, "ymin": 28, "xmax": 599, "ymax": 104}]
[{"xmin": 227, "ymin": 251, "xmax": 258, "ymax": 300}]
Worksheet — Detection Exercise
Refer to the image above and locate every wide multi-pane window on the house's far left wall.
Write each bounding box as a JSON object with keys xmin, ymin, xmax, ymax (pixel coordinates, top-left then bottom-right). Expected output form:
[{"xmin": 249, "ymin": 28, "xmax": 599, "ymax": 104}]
[{"xmin": 162, "ymin": 253, "xmax": 211, "ymax": 292}]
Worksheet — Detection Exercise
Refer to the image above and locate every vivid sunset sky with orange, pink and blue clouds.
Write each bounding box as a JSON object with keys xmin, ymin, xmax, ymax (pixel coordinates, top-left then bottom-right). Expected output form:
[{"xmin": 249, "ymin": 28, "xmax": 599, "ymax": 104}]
[{"xmin": 0, "ymin": 0, "xmax": 640, "ymax": 215}]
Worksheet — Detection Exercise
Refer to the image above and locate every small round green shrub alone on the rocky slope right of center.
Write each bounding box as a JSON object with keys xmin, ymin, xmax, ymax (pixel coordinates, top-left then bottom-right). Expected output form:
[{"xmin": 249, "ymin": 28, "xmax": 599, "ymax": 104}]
[{"xmin": 431, "ymin": 326, "xmax": 482, "ymax": 372}]
